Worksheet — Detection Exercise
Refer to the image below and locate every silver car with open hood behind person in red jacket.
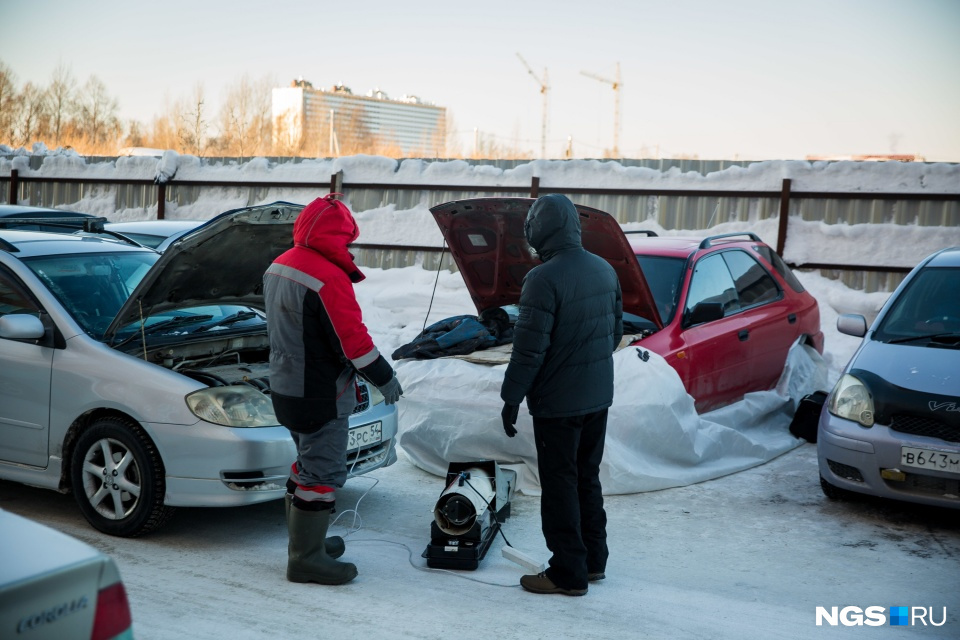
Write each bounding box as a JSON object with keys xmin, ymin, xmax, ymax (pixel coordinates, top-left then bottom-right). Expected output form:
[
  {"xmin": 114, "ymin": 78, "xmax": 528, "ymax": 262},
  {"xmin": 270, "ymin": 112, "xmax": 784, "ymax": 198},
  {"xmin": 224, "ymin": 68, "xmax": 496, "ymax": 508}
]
[{"xmin": 0, "ymin": 203, "xmax": 397, "ymax": 536}]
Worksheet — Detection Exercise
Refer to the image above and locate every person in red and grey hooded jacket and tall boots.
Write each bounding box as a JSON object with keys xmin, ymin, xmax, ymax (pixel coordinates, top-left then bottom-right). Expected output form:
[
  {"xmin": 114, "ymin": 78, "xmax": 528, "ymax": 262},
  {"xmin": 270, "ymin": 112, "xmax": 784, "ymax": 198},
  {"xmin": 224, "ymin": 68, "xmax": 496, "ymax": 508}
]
[{"xmin": 263, "ymin": 194, "xmax": 403, "ymax": 584}]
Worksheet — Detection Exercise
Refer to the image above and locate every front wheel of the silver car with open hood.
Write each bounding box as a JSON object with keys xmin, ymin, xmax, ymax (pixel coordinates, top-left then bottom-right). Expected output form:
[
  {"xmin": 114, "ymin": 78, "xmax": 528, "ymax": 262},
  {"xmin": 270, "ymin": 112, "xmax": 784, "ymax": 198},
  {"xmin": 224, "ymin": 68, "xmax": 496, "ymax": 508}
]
[{"xmin": 70, "ymin": 417, "xmax": 173, "ymax": 537}]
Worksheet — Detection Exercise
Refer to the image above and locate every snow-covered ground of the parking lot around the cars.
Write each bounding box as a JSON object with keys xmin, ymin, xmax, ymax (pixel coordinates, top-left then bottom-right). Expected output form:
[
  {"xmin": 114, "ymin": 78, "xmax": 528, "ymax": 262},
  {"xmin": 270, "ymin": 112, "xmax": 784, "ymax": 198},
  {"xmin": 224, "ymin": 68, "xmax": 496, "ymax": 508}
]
[{"xmin": 0, "ymin": 267, "xmax": 960, "ymax": 640}]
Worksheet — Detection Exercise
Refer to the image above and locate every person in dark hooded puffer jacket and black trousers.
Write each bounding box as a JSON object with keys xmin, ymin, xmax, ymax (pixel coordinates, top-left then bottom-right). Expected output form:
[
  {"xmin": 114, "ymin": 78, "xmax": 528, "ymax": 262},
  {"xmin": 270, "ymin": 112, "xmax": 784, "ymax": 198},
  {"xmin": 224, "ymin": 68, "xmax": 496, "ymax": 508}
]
[{"xmin": 500, "ymin": 194, "xmax": 623, "ymax": 596}]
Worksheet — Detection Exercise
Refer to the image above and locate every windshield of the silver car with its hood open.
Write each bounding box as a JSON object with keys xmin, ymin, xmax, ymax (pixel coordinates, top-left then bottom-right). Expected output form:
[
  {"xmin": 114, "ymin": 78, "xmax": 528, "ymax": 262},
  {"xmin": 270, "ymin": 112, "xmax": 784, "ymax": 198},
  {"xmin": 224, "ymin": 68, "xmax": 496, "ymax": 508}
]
[{"xmin": 24, "ymin": 251, "xmax": 159, "ymax": 338}]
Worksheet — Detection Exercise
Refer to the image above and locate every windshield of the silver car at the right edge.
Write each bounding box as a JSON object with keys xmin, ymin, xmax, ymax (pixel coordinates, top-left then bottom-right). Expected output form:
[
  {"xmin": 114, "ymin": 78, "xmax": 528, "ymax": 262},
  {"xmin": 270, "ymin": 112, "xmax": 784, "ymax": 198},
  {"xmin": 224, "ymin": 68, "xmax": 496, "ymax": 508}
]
[{"xmin": 874, "ymin": 267, "xmax": 960, "ymax": 345}]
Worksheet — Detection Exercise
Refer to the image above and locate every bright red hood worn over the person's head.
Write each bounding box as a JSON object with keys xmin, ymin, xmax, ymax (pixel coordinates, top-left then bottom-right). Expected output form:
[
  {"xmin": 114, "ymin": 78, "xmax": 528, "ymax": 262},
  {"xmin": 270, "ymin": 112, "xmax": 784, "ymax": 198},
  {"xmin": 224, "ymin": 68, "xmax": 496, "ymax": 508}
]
[{"xmin": 293, "ymin": 193, "xmax": 365, "ymax": 282}]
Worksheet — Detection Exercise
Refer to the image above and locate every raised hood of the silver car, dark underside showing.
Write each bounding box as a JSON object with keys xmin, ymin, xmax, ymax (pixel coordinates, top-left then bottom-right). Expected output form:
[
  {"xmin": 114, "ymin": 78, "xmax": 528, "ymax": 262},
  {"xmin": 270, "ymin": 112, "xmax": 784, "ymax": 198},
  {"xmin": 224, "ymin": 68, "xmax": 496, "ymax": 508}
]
[{"xmin": 104, "ymin": 202, "xmax": 303, "ymax": 343}]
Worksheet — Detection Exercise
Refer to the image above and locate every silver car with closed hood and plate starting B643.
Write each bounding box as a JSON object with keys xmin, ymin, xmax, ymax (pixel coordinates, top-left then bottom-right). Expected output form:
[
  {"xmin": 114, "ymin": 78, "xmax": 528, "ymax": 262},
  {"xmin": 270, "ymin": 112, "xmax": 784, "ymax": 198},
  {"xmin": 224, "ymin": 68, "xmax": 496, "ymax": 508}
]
[{"xmin": 817, "ymin": 247, "xmax": 960, "ymax": 509}]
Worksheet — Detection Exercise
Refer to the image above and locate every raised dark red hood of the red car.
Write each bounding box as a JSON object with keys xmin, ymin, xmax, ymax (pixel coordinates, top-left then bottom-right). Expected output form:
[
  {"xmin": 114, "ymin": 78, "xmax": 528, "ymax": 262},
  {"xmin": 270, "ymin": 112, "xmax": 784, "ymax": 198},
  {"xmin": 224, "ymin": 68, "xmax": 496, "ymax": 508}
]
[{"xmin": 430, "ymin": 198, "xmax": 663, "ymax": 328}]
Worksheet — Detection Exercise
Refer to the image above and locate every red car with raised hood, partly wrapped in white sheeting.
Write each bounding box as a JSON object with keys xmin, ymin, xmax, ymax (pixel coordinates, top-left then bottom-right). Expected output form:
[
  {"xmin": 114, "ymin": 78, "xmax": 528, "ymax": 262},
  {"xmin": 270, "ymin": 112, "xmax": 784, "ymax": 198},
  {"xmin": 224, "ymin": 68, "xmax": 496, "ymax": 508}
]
[{"xmin": 431, "ymin": 198, "xmax": 823, "ymax": 413}]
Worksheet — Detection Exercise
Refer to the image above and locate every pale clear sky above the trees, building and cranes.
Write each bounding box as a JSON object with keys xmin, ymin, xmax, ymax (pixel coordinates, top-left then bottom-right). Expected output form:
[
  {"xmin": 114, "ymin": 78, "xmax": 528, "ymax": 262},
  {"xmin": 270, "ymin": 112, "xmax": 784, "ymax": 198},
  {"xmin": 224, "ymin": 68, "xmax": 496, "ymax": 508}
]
[{"xmin": 0, "ymin": 0, "xmax": 960, "ymax": 162}]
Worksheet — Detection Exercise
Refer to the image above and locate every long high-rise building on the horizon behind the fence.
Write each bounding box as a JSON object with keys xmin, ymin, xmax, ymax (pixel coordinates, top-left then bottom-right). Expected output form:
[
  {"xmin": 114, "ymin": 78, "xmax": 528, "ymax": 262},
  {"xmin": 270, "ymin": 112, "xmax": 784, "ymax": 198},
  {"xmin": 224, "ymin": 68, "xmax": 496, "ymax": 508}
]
[{"xmin": 273, "ymin": 78, "xmax": 447, "ymax": 157}]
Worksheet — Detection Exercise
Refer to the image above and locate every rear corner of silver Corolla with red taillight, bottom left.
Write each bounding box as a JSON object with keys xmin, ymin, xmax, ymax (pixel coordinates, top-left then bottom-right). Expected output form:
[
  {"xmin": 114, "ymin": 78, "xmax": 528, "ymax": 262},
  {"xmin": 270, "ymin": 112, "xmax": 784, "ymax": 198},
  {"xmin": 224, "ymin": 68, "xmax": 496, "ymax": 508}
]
[{"xmin": 0, "ymin": 509, "xmax": 133, "ymax": 640}]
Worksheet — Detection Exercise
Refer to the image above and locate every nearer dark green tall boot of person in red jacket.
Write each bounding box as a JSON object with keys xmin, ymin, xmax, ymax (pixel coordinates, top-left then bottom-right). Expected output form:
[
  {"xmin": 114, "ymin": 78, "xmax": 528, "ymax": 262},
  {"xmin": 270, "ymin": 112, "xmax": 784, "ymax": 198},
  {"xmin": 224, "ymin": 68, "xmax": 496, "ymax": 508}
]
[{"xmin": 287, "ymin": 505, "xmax": 357, "ymax": 584}]
